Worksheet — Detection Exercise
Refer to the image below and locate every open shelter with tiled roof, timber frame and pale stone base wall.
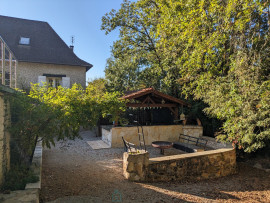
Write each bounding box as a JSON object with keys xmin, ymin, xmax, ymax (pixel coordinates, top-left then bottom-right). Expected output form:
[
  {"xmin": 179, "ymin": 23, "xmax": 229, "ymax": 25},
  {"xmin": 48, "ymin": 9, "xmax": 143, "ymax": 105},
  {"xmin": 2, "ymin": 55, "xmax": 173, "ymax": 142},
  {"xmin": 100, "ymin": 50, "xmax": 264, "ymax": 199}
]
[{"xmin": 101, "ymin": 88, "xmax": 203, "ymax": 147}]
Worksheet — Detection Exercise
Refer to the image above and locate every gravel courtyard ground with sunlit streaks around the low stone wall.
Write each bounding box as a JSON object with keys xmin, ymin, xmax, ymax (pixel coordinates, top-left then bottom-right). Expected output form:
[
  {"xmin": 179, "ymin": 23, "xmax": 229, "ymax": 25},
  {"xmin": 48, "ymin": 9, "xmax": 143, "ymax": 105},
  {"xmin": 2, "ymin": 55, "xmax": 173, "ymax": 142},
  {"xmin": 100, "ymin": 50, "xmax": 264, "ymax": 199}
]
[{"xmin": 41, "ymin": 131, "xmax": 270, "ymax": 203}]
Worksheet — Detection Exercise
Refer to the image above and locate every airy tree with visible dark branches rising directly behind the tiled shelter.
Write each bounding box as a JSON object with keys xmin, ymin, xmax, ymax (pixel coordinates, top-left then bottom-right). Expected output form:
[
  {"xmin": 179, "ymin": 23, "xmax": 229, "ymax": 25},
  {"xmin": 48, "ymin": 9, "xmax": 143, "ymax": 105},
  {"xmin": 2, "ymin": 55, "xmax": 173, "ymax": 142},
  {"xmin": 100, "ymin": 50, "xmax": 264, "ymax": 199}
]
[{"xmin": 101, "ymin": 0, "xmax": 179, "ymax": 96}]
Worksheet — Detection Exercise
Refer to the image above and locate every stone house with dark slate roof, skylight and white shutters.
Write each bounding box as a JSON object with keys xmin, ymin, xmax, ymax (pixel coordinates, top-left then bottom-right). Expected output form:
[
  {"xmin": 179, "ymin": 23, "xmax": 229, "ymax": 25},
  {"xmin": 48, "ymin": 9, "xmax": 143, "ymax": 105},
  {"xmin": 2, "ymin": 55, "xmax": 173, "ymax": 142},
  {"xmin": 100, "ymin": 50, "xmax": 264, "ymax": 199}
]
[{"xmin": 0, "ymin": 16, "xmax": 92, "ymax": 89}]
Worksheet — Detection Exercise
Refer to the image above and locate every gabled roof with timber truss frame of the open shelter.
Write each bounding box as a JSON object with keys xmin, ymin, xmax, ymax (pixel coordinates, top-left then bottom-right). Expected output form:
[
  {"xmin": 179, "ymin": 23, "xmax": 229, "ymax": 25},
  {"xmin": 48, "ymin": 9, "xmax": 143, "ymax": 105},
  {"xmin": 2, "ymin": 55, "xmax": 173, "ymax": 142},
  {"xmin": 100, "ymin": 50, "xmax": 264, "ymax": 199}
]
[{"xmin": 122, "ymin": 88, "xmax": 191, "ymax": 123}]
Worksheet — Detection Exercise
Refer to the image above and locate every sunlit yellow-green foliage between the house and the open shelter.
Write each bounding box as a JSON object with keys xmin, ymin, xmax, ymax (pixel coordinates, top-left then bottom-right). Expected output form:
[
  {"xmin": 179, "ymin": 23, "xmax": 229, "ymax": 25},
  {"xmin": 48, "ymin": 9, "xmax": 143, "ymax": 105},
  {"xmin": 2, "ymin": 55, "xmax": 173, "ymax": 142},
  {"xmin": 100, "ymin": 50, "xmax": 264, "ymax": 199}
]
[{"xmin": 29, "ymin": 80, "xmax": 125, "ymax": 147}]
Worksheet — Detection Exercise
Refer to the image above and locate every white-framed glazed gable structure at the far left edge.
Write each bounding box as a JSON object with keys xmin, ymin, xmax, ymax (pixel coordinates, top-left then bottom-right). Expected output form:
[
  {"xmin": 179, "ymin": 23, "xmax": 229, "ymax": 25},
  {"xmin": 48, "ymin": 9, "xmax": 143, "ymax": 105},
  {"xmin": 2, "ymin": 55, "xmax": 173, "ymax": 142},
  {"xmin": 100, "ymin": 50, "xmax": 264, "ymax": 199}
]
[{"xmin": 0, "ymin": 36, "xmax": 18, "ymax": 88}]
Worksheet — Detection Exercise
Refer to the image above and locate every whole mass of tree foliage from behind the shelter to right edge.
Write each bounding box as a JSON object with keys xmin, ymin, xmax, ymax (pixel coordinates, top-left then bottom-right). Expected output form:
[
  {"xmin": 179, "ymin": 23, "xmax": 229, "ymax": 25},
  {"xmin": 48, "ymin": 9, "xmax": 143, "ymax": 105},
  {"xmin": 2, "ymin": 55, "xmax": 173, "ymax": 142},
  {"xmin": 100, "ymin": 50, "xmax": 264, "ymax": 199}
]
[{"xmin": 102, "ymin": 0, "xmax": 270, "ymax": 152}]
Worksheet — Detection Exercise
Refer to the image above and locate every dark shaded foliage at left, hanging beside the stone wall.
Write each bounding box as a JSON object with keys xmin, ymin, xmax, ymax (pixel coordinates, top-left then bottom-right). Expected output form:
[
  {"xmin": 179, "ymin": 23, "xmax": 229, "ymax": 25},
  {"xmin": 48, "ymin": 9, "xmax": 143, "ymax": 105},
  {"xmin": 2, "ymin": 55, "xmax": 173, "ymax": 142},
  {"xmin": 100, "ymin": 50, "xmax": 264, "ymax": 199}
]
[{"xmin": 9, "ymin": 89, "xmax": 57, "ymax": 165}]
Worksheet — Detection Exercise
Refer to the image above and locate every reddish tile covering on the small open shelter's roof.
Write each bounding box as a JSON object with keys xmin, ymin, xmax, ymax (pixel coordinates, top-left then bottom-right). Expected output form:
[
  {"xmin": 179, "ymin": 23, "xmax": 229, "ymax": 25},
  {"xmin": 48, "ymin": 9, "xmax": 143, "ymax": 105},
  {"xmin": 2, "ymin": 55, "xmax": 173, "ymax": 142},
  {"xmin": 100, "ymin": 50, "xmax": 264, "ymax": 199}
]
[{"xmin": 122, "ymin": 87, "xmax": 191, "ymax": 106}]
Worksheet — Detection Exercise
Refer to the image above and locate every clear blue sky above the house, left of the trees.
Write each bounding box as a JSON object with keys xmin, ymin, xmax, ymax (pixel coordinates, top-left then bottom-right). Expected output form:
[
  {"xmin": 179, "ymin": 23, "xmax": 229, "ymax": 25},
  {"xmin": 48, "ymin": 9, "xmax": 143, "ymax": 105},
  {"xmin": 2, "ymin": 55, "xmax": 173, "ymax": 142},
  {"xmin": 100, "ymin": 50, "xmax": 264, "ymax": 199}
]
[{"xmin": 0, "ymin": 0, "xmax": 123, "ymax": 80}]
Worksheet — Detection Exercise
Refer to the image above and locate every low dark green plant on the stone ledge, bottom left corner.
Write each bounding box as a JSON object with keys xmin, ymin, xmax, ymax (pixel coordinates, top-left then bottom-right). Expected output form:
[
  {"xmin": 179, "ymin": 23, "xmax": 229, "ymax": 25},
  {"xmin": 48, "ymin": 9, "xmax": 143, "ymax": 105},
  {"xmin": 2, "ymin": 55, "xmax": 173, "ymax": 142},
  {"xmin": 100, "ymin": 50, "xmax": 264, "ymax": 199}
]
[{"xmin": 1, "ymin": 165, "xmax": 39, "ymax": 191}]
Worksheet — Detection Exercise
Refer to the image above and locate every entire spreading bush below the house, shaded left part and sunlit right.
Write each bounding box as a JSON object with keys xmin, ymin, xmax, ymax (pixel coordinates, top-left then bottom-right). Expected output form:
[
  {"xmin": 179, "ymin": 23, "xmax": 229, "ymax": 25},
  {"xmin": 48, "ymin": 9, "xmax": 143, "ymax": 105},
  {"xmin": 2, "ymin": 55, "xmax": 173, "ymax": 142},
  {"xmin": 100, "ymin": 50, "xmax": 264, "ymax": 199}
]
[{"xmin": 10, "ymin": 80, "xmax": 125, "ymax": 162}]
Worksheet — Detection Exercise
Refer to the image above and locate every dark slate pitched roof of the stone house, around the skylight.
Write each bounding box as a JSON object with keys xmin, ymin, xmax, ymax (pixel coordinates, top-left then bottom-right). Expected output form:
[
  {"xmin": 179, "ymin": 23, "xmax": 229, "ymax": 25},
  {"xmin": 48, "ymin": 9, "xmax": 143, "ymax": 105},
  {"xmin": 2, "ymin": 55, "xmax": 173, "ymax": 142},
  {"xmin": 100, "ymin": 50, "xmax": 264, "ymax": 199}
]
[{"xmin": 0, "ymin": 15, "xmax": 93, "ymax": 70}]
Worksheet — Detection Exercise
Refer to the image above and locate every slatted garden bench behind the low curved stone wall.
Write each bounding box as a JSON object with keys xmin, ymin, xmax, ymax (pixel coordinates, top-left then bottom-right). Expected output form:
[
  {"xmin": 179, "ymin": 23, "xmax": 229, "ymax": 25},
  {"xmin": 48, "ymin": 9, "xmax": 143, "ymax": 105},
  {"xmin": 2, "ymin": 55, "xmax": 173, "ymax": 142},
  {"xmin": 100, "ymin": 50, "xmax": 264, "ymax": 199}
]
[{"xmin": 173, "ymin": 134, "xmax": 208, "ymax": 153}]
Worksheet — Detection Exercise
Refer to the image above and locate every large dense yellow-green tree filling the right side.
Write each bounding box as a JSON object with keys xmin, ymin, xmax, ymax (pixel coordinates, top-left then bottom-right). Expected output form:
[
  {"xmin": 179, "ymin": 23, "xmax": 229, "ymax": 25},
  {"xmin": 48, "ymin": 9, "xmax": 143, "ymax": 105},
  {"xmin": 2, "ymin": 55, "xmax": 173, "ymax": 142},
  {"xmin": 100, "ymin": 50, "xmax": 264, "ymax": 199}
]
[{"xmin": 146, "ymin": 0, "xmax": 270, "ymax": 152}]
